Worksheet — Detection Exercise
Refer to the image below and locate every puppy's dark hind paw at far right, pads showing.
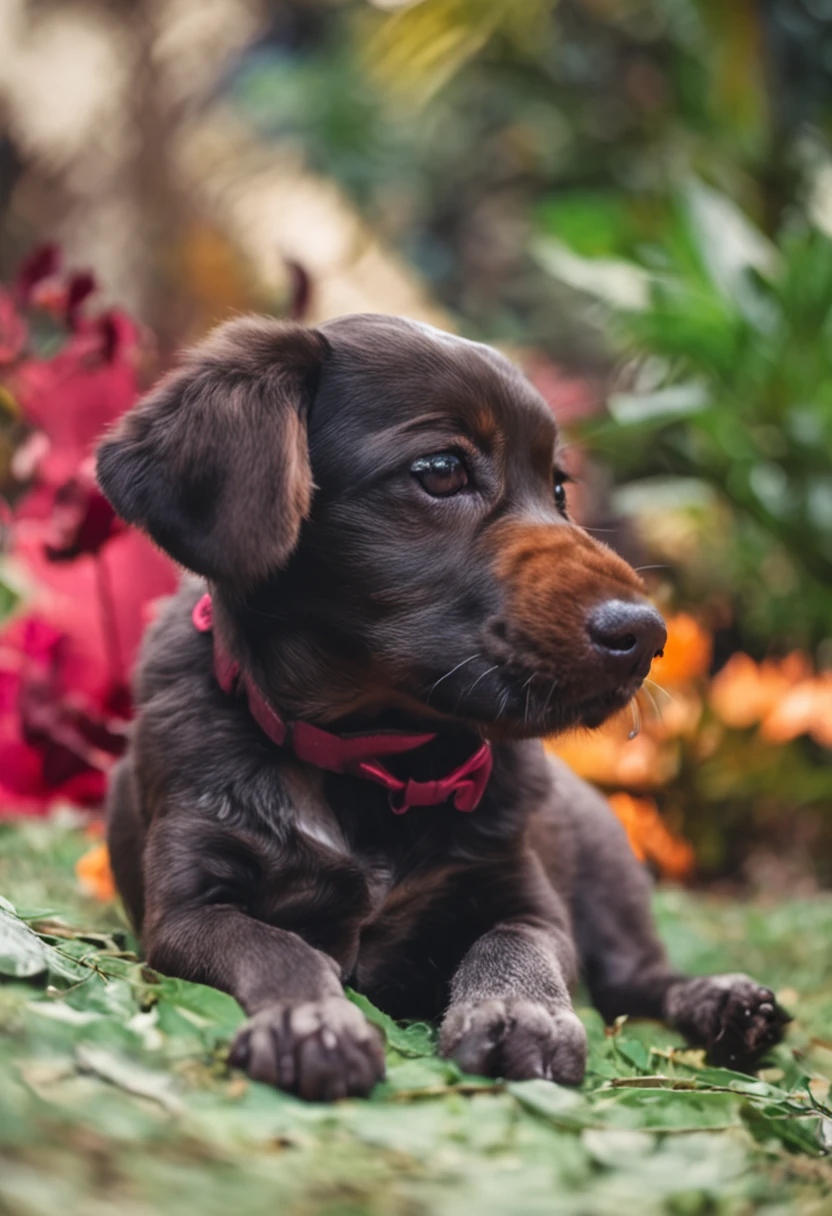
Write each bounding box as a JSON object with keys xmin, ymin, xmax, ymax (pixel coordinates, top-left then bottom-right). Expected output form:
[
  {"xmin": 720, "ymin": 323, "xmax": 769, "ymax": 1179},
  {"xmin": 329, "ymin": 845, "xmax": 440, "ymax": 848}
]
[{"xmin": 665, "ymin": 974, "xmax": 792, "ymax": 1073}]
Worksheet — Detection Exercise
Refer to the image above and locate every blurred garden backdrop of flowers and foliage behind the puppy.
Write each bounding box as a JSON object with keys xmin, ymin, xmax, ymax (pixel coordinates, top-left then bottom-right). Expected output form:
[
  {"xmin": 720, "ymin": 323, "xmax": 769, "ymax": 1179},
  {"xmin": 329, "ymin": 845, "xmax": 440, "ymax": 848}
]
[{"xmin": 0, "ymin": 0, "xmax": 832, "ymax": 896}]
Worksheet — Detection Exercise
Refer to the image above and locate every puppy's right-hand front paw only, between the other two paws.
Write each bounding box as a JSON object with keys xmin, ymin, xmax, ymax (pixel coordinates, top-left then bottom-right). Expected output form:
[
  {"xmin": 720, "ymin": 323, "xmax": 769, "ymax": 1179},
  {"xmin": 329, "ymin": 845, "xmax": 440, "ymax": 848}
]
[{"xmin": 439, "ymin": 997, "xmax": 586, "ymax": 1085}]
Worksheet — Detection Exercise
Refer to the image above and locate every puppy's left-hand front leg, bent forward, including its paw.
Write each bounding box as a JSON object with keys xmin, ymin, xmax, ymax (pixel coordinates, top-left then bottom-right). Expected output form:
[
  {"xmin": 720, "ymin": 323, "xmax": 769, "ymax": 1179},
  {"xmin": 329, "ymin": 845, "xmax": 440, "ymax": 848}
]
[{"xmin": 145, "ymin": 814, "xmax": 384, "ymax": 1102}]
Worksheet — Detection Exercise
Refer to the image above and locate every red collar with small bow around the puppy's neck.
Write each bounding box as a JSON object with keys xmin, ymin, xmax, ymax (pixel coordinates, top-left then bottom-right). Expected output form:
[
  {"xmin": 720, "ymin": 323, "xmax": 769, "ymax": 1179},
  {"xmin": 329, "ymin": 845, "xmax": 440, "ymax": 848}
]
[{"xmin": 193, "ymin": 595, "xmax": 493, "ymax": 815}]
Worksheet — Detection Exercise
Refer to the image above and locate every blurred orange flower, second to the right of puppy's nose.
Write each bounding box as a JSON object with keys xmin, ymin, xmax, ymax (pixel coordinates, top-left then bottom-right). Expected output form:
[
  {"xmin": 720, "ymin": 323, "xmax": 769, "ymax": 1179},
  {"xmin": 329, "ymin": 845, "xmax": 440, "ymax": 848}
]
[{"xmin": 710, "ymin": 651, "xmax": 811, "ymax": 737}]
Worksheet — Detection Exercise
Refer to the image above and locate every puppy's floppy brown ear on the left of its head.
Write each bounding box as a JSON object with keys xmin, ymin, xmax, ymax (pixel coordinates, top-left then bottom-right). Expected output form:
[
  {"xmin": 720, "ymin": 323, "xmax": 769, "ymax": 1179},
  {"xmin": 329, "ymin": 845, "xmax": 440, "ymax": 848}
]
[{"xmin": 97, "ymin": 317, "xmax": 327, "ymax": 587}]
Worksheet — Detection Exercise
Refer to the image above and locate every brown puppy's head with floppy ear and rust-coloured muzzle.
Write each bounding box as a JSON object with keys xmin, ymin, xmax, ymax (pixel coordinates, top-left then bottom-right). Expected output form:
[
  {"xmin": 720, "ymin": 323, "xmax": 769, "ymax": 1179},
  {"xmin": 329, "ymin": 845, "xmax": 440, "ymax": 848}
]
[{"xmin": 99, "ymin": 315, "xmax": 665, "ymax": 737}]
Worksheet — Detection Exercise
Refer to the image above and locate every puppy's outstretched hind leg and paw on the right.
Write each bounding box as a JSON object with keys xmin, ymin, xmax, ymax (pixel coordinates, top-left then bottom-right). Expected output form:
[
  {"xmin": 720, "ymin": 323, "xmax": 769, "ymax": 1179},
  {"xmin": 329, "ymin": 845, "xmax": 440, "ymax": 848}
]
[{"xmin": 539, "ymin": 771, "xmax": 789, "ymax": 1070}]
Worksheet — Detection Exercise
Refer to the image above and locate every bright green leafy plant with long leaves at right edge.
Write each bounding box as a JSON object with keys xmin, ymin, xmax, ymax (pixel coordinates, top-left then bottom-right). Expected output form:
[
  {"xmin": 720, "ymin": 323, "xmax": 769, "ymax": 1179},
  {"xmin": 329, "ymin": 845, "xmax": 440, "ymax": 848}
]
[{"xmin": 538, "ymin": 181, "xmax": 832, "ymax": 646}]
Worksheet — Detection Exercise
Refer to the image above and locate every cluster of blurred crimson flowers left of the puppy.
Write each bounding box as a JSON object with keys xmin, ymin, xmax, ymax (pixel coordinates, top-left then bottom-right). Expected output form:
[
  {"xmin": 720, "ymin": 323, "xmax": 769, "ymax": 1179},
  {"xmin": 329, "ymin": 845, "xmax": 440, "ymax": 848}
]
[{"xmin": 0, "ymin": 247, "xmax": 176, "ymax": 814}]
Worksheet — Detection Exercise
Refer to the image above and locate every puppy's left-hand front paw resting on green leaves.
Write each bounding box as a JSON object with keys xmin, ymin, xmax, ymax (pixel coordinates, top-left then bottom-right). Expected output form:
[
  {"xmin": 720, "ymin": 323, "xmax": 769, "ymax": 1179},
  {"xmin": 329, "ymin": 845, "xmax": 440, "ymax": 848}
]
[{"xmin": 229, "ymin": 997, "xmax": 384, "ymax": 1102}]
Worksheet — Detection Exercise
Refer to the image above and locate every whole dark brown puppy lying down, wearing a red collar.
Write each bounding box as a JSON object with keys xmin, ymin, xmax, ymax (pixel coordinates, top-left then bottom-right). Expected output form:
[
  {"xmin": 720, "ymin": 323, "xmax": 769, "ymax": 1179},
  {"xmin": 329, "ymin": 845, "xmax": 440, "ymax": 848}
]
[{"xmin": 99, "ymin": 316, "xmax": 786, "ymax": 1098}]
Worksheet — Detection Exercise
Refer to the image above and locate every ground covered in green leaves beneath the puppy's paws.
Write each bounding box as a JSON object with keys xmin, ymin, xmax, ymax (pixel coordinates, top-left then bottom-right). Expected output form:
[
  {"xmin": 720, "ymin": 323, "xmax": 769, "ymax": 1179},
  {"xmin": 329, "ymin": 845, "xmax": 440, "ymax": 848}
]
[{"xmin": 0, "ymin": 821, "xmax": 832, "ymax": 1216}]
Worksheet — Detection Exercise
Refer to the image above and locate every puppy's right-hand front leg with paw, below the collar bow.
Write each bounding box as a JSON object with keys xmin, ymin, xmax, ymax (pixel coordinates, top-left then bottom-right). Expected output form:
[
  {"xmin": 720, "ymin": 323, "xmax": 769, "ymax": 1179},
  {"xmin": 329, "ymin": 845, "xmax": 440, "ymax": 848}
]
[{"xmin": 440, "ymin": 856, "xmax": 586, "ymax": 1085}]
